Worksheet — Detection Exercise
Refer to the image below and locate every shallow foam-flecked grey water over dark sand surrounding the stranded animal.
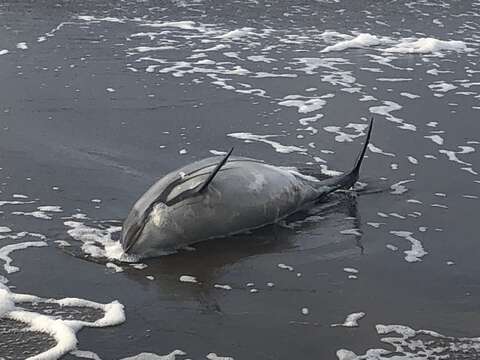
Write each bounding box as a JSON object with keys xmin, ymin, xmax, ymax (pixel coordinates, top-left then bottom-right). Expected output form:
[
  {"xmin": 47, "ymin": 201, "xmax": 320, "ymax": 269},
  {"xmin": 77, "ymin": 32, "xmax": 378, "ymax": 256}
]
[{"xmin": 0, "ymin": 0, "xmax": 480, "ymax": 359}]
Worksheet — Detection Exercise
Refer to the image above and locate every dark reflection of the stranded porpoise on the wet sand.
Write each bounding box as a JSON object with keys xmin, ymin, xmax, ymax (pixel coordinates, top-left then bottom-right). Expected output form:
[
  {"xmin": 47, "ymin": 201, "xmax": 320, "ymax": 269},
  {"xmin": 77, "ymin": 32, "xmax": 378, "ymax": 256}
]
[{"xmin": 121, "ymin": 192, "xmax": 364, "ymax": 301}]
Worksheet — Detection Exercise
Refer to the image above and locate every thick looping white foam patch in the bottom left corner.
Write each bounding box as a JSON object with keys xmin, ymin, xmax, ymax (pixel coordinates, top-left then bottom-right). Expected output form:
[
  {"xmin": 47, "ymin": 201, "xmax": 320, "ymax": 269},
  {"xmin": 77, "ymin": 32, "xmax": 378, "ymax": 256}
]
[{"xmin": 0, "ymin": 284, "xmax": 125, "ymax": 360}]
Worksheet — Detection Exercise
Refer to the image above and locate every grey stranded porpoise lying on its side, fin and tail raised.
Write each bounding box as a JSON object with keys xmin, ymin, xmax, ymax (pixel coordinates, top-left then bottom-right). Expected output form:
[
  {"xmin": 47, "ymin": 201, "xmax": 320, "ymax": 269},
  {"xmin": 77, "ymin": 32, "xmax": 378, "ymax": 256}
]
[{"xmin": 121, "ymin": 119, "xmax": 373, "ymax": 257}]
